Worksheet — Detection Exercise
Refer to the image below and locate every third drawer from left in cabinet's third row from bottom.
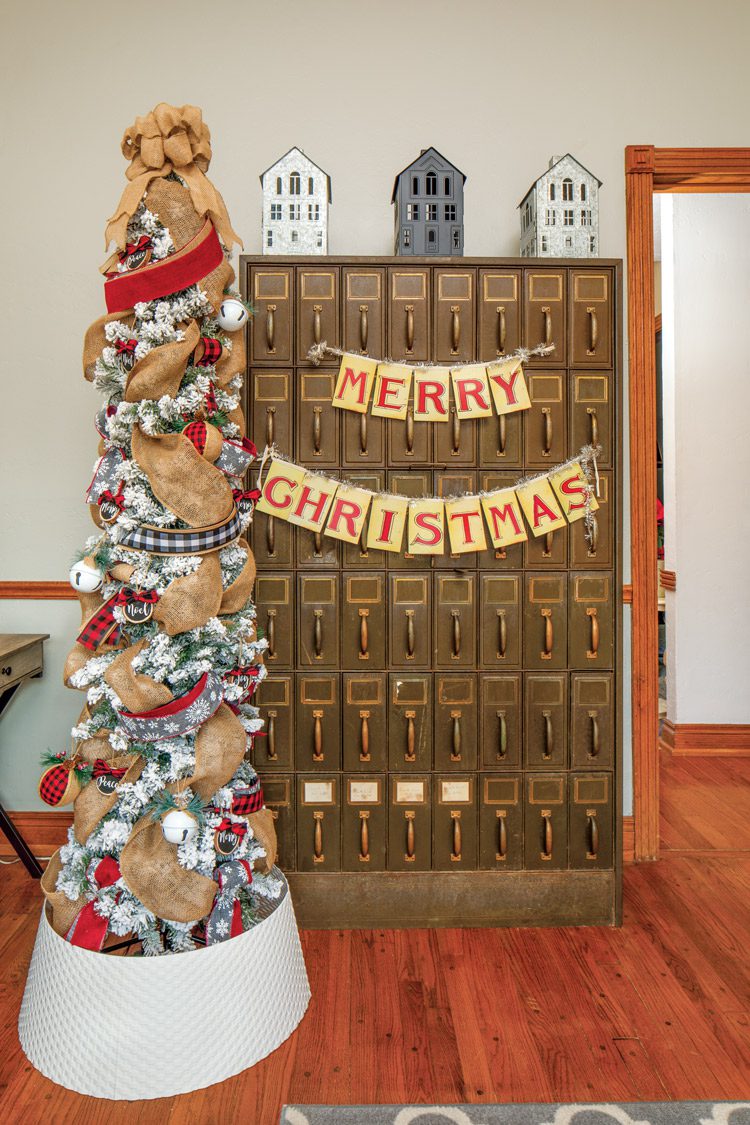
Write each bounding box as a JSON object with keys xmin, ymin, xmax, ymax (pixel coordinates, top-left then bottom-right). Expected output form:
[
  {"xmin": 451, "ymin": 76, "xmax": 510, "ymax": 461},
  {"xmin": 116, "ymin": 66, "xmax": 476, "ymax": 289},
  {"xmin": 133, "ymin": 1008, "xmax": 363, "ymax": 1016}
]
[{"xmin": 341, "ymin": 572, "xmax": 386, "ymax": 668}]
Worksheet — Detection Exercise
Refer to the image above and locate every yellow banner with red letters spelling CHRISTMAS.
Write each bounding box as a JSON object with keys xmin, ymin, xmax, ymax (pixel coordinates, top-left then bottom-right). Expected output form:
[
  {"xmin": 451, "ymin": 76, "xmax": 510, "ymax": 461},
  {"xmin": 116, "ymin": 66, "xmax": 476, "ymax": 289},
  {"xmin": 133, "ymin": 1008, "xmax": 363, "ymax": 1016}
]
[{"xmin": 255, "ymin": 446, "xmax": 599, "ymax": 555}]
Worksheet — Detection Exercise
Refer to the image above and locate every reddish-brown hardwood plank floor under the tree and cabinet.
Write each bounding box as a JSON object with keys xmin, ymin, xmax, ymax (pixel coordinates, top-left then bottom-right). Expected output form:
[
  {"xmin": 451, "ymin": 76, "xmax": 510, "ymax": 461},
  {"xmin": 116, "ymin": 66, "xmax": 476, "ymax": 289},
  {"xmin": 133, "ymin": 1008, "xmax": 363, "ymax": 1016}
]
[{"xmin": 0, "ymin": 758, "xmax": 750, "ymax": 1125}]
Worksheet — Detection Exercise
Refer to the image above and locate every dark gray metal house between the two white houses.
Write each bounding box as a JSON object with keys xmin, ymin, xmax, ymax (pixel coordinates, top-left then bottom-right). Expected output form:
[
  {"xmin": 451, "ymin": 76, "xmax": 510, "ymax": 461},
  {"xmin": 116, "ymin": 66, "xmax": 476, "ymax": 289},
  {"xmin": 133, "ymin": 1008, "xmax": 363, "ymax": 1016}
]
[{"xmin": 390, "ymin": 149, "xmax": 467, "ymax": 258}]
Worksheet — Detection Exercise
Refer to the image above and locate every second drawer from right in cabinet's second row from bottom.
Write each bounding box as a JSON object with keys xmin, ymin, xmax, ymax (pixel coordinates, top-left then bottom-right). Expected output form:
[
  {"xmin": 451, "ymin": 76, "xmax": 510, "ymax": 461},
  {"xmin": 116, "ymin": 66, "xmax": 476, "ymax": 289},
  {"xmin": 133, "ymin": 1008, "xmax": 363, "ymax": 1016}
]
[{"xmin": 524, "ymin": 672, "xmax": 568, "ymax": 770}]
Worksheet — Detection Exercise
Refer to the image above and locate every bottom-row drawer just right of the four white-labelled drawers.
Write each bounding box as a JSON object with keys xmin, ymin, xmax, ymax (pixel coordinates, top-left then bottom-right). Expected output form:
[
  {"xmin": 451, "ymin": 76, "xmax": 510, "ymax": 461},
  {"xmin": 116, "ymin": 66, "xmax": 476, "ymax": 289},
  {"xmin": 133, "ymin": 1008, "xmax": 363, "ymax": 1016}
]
[{"xmin": 479, "ymin": 774, "xmax": 524, "ymax": 871}]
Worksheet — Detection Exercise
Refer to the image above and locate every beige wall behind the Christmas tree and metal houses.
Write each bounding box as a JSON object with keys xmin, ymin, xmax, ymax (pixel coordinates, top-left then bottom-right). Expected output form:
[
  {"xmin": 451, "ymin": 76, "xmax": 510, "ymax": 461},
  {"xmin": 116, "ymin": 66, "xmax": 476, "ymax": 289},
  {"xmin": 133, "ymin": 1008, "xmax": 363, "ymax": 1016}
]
[{"xmin": 0, "ymin": 0, "xmax": 750, "ymax": 809}]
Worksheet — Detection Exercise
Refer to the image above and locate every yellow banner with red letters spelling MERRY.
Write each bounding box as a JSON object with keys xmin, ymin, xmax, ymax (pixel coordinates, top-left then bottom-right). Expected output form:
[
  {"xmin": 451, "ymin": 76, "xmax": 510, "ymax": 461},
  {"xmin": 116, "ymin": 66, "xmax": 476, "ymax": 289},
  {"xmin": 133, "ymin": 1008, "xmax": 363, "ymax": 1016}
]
[{"xmin": 308, "ymin": 344, "xmax": 554, "ymax": 422}]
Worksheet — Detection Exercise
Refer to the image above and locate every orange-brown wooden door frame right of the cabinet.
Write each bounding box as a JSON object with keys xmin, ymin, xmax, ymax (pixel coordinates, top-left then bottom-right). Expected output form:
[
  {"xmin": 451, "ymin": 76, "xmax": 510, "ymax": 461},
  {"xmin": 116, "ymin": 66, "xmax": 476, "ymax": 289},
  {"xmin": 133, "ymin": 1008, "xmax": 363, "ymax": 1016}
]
[{"xmin": 625, "ymin": 145, "xmax": 750, "ymax": 862}]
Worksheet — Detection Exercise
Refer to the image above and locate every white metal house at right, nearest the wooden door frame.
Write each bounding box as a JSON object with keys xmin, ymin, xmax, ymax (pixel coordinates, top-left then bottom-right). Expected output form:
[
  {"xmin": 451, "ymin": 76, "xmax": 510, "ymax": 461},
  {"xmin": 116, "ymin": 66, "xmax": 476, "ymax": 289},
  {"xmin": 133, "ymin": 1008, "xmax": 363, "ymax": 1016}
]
[{"xmin": 518, "ymin": 153, "xmax": 602, "ymax": 258}]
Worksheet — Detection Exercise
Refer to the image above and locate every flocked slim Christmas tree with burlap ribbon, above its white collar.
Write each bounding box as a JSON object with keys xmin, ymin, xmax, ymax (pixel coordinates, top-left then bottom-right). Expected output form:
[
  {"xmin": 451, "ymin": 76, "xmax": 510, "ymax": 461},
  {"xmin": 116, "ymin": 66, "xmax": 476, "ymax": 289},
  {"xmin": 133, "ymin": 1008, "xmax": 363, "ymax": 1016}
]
[{"xmin": 39, "ymin": 105, "xmax": 283, "ymax": 954}]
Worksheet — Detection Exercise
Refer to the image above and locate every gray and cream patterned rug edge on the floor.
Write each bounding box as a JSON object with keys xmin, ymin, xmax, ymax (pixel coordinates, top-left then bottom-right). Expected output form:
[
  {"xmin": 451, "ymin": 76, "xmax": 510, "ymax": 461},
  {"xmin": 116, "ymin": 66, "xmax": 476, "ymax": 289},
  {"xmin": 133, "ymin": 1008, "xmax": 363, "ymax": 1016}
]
[{"xmin": 281, "ymin": 1101, "xmax": 750, "ymax": 1125}]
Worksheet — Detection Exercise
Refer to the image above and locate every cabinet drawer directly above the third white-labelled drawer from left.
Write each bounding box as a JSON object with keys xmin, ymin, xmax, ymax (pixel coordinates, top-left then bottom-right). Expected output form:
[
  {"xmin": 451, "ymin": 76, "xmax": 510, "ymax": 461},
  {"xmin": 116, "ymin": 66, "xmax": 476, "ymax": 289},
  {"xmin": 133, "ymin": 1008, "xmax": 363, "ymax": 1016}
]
[{"xmin": 388, "ymin": 672, "xmax": 433, "ymax": 770}]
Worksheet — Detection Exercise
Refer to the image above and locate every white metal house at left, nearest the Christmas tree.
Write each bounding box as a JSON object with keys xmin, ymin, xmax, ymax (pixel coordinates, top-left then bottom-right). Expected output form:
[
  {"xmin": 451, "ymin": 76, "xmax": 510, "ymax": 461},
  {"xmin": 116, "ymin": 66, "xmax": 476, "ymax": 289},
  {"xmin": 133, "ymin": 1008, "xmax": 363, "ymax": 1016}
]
[{"xmin": 261, "ymin": 147, "xmax": 331, "ymax": 254}]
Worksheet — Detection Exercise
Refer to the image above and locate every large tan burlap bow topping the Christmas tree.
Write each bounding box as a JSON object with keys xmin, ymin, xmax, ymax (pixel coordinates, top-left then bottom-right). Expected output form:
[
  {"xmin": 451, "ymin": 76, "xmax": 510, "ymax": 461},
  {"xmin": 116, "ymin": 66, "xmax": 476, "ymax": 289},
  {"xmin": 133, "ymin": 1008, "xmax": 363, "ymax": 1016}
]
[{"xmin": 105, "ymin": 102, "xmax": 242, "ymax": 256}]
